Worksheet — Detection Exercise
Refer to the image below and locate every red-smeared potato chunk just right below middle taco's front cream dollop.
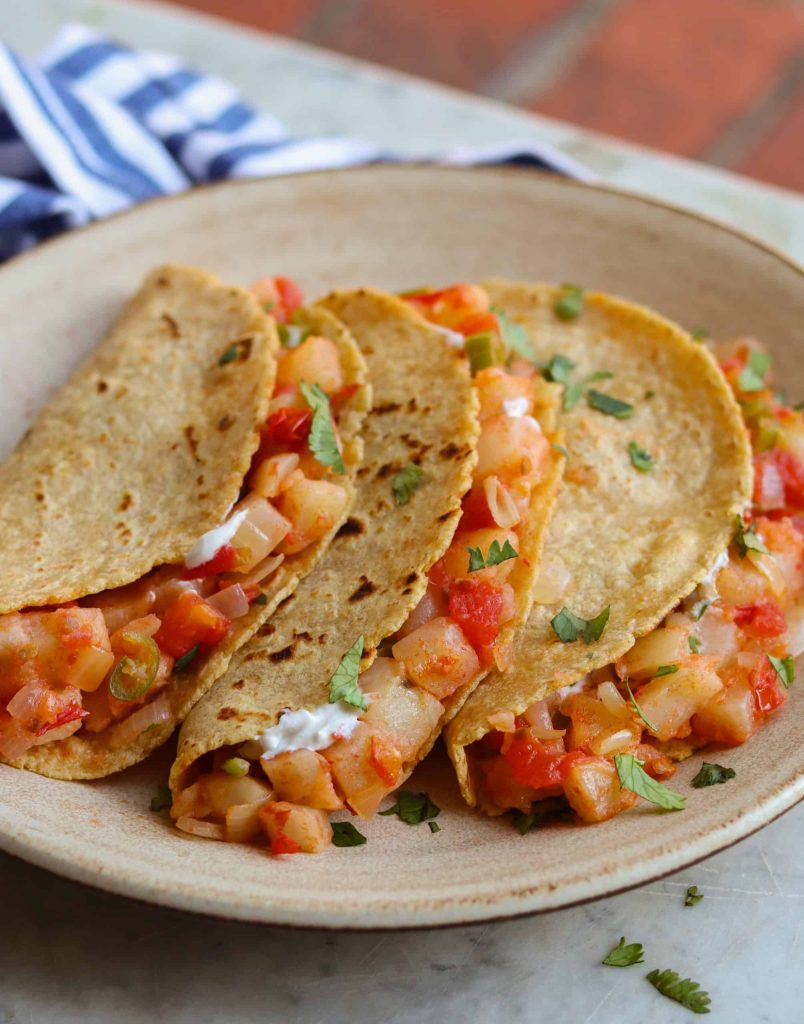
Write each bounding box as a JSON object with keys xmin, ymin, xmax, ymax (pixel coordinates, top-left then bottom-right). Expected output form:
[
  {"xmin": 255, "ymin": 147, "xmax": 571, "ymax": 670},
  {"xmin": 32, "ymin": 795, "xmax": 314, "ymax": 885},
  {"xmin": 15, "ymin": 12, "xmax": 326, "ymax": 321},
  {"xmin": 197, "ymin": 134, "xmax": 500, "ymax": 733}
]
[{"xmin": 324, "ymin": 723, "xmax": 401, "ymax": 818}]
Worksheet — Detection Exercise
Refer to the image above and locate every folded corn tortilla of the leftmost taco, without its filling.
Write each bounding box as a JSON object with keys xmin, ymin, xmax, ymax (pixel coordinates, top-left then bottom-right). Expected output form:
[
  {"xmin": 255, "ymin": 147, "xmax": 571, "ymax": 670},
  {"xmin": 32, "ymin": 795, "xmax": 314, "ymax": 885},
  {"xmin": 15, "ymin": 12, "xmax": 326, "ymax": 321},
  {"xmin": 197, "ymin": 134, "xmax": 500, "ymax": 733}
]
[{"xmin": 0, "ymin": 266, "xmax": 371, "ymax": 779}]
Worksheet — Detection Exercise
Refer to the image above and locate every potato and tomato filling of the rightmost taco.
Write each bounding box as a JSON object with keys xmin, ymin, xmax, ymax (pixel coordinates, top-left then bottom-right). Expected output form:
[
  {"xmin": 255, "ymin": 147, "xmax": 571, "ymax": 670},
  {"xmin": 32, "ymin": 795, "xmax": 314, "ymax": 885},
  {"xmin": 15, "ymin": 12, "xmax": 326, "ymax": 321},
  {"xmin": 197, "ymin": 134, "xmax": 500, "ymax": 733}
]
[{"xmin": 466, "ymin": 339, "xmax": 804, "ymax": 822}]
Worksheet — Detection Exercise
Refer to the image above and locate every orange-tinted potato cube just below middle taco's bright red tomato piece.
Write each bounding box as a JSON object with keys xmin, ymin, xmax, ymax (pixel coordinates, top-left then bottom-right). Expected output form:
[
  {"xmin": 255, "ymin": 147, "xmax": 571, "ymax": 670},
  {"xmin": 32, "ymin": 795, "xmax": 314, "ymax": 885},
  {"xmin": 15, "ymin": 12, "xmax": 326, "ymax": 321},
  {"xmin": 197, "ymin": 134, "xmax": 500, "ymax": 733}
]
[{"xmin": 391, "ymin": 617, "xmax": 480, "ymax": 700}]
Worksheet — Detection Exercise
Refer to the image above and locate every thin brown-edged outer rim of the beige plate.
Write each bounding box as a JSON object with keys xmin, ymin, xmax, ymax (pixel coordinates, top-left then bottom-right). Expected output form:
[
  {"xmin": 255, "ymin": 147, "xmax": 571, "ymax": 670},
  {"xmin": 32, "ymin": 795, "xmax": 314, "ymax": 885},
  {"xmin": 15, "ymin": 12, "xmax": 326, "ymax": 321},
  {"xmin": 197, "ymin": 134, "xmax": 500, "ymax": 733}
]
[{"xmin": 0, "ymin": 161, "xmax": 804, "ymax": 932}]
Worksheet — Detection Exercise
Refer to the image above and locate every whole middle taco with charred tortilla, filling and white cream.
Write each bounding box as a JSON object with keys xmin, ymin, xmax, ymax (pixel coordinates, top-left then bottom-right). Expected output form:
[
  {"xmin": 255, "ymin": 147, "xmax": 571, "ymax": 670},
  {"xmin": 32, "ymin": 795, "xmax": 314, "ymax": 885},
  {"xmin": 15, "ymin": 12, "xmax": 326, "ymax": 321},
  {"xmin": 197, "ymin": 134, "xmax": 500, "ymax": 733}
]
[{"xmin": 165, "ymin": 286, "xmax": 561, "ymax": 853}]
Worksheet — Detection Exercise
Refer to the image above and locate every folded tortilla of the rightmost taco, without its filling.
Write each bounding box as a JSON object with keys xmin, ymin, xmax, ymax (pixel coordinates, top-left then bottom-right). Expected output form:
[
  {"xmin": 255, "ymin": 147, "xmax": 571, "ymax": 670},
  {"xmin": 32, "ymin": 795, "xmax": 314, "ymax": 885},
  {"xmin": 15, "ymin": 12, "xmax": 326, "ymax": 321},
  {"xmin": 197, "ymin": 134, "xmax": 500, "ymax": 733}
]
[{"xmin": 445, "ymin": 281, "xmax": 752, "ymax": 806}]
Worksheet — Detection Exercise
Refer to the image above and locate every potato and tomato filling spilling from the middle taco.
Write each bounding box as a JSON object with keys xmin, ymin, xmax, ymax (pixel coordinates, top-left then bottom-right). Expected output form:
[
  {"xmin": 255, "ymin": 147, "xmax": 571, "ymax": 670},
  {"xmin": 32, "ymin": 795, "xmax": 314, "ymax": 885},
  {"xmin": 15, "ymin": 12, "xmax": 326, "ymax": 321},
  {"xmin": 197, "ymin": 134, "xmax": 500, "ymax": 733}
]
[{"xmin": 171, "ymin": 285, "xmax": 556, "ymax": 853}]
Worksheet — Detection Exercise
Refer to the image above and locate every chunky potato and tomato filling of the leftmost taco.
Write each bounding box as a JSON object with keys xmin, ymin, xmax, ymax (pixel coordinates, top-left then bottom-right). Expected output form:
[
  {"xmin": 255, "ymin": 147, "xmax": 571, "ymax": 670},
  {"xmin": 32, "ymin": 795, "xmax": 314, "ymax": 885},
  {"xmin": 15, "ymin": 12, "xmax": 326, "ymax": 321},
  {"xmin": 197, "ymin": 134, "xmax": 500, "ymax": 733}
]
[{"xmin": 0, "ymin": 279, "xmax": 358, "ymax": 761}]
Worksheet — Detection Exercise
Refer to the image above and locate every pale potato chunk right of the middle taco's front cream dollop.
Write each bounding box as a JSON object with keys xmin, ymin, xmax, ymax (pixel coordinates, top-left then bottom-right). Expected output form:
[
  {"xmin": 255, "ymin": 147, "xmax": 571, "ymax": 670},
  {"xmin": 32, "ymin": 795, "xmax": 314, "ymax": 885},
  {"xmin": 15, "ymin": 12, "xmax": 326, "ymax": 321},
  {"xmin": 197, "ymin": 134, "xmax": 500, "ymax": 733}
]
[{"xmin": 361, "ymin": 657, "xmax": 443, "ymax": 763}]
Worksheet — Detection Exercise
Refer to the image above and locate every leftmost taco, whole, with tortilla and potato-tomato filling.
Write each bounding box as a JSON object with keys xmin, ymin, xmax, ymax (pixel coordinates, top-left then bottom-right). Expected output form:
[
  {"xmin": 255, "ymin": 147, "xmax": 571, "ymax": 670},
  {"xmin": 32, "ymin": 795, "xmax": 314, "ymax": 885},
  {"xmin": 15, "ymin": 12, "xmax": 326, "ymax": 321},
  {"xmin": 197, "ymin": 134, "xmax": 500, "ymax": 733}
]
[{"xmin": 0, "ymin": 266, "xmax": 370, "ymax": 778}]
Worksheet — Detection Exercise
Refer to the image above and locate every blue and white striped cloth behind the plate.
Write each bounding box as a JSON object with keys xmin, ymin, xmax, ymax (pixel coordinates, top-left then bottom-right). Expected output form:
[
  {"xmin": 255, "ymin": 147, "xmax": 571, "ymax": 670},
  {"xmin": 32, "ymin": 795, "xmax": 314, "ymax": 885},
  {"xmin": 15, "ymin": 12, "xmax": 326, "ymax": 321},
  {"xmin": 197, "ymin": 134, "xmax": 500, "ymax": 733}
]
[{"xmin": 0, "ymin": 25, "xmax": 590, "ymax": 260}]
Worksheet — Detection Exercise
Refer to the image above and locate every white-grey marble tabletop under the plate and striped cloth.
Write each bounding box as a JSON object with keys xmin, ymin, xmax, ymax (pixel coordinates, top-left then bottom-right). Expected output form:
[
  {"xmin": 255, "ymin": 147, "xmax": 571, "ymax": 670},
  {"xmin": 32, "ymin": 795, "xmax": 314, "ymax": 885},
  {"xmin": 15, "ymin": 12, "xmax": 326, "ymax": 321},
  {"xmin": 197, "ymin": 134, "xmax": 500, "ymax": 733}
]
[{"xmin": 0, "ymin": 0, "xmax": 804, "ymax": 1024}]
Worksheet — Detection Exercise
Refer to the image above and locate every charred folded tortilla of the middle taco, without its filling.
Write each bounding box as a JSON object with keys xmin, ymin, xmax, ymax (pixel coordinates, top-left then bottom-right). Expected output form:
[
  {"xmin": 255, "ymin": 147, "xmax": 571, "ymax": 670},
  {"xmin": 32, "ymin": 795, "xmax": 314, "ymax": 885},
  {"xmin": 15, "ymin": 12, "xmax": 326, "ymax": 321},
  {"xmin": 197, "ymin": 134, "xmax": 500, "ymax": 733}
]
[{"xmin": 170, "ymin": 290, "xmax": 478, "ymax": 793}]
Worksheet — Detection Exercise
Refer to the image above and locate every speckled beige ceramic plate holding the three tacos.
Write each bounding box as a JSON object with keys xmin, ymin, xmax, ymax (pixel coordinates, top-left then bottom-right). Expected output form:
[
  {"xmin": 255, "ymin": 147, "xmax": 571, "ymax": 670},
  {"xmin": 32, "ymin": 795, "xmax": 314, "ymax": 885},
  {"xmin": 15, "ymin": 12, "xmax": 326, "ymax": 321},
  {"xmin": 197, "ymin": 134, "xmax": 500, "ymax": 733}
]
[{"xmin": 0, "ymin": 168, "xmax": 804, "ymax": 928}]
